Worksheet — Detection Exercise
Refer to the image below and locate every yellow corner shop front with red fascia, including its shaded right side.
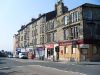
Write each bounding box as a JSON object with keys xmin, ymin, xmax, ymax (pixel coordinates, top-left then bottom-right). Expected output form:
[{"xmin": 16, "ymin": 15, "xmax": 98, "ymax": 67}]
[{"xmin": 59, "ymin": 40, "xmax": 100, "ymax": 62}]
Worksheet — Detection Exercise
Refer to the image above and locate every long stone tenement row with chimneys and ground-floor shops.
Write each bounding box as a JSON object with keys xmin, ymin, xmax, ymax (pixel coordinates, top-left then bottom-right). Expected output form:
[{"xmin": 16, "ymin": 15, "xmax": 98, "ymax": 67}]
[{"xmin": 13, "ymin": 0, "xmax": 100, "ymax": 62}]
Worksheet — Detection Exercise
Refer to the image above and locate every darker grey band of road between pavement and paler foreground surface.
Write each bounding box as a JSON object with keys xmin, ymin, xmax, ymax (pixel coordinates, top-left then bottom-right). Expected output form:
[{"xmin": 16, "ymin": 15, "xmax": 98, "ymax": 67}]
[{"xmin": 0, "ymin": 58, "xmax": 100, "ymax": 75}]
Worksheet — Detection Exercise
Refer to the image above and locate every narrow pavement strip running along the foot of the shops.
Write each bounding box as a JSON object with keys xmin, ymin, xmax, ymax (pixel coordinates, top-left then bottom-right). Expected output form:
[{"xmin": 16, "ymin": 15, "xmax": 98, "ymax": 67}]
[{"xmin": 10, "ymin": 58, "xmax": 100, "ymax": 65}]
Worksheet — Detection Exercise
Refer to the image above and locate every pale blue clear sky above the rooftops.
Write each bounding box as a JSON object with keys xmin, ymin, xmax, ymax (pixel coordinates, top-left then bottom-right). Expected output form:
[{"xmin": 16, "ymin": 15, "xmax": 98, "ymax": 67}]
[{"xmin": 0, "ymin": 0, "xmax": 100, "ymax": 51}]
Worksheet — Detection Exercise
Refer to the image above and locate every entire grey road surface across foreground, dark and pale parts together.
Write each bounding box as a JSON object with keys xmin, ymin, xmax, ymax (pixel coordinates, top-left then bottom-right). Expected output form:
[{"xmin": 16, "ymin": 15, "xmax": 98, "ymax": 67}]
[{"xmin": 0, "ymin": 58, "xmax": 100, "ymax": 75}]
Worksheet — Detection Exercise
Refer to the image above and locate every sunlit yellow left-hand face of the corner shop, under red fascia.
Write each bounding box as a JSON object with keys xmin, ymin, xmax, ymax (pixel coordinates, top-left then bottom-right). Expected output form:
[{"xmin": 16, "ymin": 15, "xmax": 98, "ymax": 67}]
[{"xmin": 59, "ymin": 40, "xmax": 80, "ymax": 62}]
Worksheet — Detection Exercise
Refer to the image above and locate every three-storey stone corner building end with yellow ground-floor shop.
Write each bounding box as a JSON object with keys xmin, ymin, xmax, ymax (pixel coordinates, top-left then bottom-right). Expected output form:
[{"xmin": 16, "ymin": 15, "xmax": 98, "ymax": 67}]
[{"xmin": 59, "ymin": 3, "xmax": 100, "ymax": 61}]
